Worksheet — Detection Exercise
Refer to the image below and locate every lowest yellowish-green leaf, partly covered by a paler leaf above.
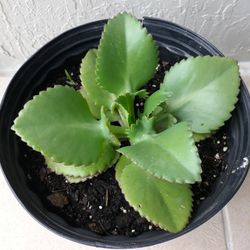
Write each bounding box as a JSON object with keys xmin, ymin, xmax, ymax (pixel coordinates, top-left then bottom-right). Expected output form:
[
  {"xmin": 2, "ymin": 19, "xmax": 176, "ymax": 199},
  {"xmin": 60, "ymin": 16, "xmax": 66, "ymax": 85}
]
[{"xmin": 116, "ymin": 157, "xmax": 192, "ymax": 233}]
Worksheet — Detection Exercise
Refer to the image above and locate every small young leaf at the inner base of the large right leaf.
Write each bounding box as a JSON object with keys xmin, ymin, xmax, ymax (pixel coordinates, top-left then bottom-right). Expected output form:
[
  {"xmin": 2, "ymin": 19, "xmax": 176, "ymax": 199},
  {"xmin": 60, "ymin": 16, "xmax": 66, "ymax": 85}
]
[{"xmin": 143, "ymin": 89, "xmax": 171, "ymax": 116}]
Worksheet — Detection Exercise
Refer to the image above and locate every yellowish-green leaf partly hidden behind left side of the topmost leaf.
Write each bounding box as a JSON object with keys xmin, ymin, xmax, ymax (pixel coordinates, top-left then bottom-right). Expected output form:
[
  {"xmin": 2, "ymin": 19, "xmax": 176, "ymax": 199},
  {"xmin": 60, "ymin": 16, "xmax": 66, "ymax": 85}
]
[{"xmin": 80, "ymin": 49, "xmax": 115, "ymax": 113}]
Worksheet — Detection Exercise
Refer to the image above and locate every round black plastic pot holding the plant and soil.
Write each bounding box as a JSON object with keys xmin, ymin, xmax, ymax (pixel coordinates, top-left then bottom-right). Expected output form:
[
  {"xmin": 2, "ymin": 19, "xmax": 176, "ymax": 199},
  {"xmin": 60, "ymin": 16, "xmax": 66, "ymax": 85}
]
[{"xmin": 0, "ymin": 18, "xmax": 250, "ymax": 248}]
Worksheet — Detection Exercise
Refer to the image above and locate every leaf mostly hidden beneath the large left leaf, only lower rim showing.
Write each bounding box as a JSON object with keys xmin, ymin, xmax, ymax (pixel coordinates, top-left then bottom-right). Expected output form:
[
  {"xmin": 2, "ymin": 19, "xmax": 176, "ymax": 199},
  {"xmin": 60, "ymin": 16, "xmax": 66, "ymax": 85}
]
[{"xmin": 45, "ymin": 144, "xmax": 118, "ymax": 182}]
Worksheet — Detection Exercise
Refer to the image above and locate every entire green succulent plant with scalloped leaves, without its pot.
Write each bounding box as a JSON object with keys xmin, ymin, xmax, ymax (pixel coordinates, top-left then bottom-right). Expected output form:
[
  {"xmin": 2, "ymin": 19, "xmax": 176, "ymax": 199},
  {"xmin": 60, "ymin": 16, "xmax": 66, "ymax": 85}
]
[{"xmin": 13, "ymin": 14, "xmax": 240, "ymax": 232}]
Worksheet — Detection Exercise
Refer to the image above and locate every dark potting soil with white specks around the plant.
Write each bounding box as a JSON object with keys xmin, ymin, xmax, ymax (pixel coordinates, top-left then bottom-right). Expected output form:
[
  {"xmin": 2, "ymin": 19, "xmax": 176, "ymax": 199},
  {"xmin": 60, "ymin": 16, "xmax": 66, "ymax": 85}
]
[{"xmin": 19, "ymin": 62, "xmax": 228, "ymax": 236}]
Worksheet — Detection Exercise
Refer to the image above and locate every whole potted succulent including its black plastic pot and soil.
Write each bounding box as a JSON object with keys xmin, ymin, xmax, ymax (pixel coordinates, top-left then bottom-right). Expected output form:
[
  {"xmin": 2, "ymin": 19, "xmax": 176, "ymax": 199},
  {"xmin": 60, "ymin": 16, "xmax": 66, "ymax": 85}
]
[{"xmin": 0, "ymin": 14, "xmax": 249, "ymax": 247}]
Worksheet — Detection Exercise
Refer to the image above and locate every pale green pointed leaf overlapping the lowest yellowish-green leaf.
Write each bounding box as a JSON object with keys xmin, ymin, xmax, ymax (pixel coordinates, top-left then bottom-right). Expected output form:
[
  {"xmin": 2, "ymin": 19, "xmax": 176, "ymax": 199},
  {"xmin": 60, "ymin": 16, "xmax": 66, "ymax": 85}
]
[{"xmin": 118, "ymin": 122, "xmax": 201, "ymax": 183}]
